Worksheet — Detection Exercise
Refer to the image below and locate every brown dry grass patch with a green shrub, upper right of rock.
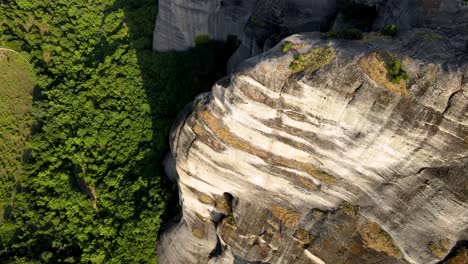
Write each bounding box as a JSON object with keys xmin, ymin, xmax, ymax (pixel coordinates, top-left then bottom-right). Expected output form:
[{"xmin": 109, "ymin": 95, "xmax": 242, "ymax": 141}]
[{"xmin": 358, "ymin": 52, "xmax": 409, "ymax": 96}]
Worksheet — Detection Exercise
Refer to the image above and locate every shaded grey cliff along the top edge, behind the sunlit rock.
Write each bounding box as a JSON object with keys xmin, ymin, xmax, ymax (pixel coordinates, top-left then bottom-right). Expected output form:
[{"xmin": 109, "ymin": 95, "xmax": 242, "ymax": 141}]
[{"xmin": 153, "ymin": 0, "xmax": 468, "ymax": 69}]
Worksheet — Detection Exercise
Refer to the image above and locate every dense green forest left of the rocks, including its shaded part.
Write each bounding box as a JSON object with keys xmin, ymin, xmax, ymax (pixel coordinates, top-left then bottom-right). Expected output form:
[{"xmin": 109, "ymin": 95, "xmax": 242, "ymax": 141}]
[{"xmin": 0, "ymin": 0, "xmax": 236, "ymax": 263}]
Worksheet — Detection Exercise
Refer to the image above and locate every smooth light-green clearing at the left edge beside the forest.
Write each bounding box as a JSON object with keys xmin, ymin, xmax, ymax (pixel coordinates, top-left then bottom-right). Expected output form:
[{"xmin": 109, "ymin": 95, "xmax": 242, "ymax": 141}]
[{"xmin": 0, "ymin": 48, "xmax": 35, "ymax": 223}]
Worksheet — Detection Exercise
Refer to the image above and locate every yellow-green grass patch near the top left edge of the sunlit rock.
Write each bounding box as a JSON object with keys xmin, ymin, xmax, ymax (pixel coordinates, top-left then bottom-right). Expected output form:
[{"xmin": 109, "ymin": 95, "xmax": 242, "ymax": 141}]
[{"xmin": 290, "ymin": 46, "xmax": 335, "ymax": 74}]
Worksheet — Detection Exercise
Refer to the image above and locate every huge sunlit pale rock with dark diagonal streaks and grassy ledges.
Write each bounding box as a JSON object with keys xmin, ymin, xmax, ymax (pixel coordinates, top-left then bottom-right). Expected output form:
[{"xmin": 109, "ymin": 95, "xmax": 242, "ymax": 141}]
[{"xmin": 158, "ymin": 29, "xmax": 468, "ymax": 264}]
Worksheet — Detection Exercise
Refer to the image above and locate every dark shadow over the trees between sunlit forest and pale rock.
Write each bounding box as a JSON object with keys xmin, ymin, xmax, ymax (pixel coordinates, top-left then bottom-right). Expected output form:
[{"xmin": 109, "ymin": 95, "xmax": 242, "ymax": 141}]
[{"xmin": 109, "ymin": 0, "xmax": 239, "ymax": 230}]
